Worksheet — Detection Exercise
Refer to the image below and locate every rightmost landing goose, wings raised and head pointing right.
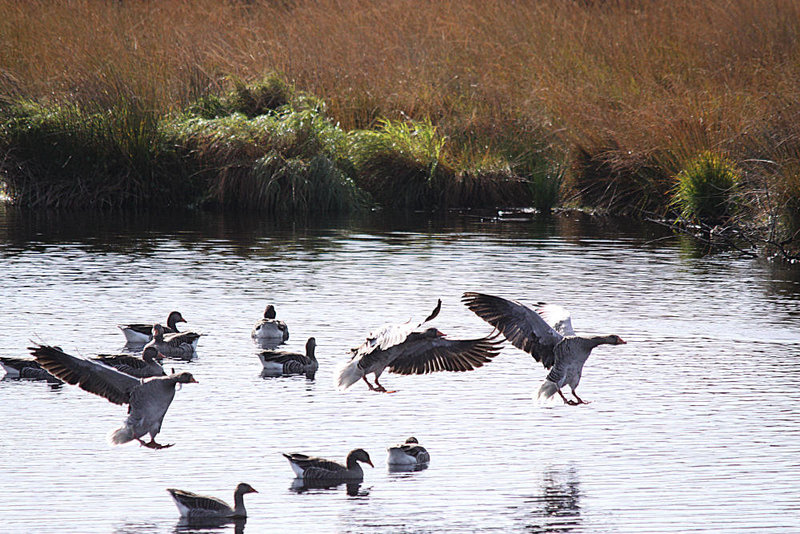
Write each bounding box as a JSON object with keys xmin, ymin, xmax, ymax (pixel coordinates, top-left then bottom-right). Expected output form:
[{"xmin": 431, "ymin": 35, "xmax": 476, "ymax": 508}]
[{"xmin": 461, "ymin": 292, "xmax": 626, "ymax": 406}]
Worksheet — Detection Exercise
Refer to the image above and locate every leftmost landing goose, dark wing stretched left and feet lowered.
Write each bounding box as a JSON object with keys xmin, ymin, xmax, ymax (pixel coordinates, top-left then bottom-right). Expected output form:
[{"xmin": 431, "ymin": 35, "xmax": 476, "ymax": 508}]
[{"xmin": 29, "ymin": 345, "xmax": 197, "ymax": 449}]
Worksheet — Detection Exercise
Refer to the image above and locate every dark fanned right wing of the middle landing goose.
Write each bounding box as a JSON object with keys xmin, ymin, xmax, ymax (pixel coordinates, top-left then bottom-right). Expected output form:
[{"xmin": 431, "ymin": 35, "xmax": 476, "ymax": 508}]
[{"xmin": 388, "ymin": 332, "xmax": 502, "ymax": 375}]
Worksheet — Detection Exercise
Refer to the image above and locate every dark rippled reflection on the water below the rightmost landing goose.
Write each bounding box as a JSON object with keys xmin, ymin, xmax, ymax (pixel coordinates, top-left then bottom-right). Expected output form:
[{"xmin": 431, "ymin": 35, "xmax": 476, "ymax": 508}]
[{"xmin": 521, "ymin": 468, "xmax": 582, "ymax": 533}]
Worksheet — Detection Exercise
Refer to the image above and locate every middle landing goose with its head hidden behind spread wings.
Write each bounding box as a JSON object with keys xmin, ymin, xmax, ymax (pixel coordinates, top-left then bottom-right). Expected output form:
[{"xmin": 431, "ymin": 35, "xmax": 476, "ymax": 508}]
[{"xmin": 338, "ymin": 300, "xmax": 502, "ymax": 393}]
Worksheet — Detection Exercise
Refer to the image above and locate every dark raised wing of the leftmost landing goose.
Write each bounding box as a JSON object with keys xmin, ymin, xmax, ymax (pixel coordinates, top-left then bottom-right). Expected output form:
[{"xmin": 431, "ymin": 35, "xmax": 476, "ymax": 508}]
[{"xmin": 28, "ymin": 345, "xmax": 140, "ymax": 404}]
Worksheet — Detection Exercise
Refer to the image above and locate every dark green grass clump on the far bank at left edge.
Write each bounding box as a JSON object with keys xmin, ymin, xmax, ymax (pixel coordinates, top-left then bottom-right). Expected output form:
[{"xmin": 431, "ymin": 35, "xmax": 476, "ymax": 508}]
[{"xmin": 0, "ymin": 101, "xmax": 193, "ymax": 208}]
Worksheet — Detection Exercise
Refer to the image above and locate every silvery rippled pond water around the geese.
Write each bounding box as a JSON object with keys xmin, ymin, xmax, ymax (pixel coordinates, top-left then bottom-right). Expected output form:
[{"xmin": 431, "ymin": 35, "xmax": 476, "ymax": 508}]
[{"xmin": 0, "ymin": 208, "xmax": 800, "ymax": 533}]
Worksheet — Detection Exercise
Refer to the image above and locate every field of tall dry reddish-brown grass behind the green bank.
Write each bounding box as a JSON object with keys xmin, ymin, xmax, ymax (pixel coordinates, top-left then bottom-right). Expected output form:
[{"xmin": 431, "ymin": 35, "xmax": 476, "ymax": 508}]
[{"xmin": 0, "ymin": 0, "xmax": 800, "ymax": 216}]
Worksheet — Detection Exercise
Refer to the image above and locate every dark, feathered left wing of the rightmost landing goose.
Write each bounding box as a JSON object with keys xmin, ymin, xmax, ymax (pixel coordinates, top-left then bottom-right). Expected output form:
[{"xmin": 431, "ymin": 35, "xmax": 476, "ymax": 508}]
[{"xmin": 461, "ymin": 293, "xmax": 572, "ymax": 369}]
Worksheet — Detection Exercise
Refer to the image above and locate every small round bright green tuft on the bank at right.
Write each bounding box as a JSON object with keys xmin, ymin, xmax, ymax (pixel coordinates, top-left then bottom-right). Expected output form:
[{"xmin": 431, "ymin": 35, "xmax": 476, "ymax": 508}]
[{"xmin": 672, "ymin": 151, "xmax": 741, "ymax": 225}]
